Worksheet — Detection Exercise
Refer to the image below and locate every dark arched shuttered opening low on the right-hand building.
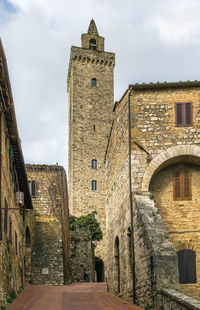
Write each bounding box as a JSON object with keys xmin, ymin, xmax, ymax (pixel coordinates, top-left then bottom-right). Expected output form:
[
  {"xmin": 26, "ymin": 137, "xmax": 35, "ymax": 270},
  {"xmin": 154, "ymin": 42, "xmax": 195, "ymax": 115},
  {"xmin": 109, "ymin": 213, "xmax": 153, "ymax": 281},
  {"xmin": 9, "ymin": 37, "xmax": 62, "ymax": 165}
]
[{"xmin": 177, "ymin": 250, "xmax": 196, "ymax": 284}]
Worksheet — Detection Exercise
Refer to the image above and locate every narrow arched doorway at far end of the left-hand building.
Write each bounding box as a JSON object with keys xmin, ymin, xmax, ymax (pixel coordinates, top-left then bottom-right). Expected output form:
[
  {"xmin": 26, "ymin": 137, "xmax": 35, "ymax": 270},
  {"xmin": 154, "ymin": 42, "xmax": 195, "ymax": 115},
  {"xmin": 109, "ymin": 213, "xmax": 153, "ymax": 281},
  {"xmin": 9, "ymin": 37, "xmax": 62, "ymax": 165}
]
[{"xmin": 24, "ymin": 226, "xmax": 31, "ymax": 283}]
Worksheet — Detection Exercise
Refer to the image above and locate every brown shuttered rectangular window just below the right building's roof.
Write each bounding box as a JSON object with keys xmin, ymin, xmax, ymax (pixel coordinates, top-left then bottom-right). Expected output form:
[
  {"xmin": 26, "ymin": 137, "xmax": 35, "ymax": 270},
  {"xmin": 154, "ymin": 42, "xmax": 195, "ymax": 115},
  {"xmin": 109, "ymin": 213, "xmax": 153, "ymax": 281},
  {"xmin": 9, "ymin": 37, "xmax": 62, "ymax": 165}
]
[{"xmin": 175, "ymin": 102, "xmax": 192, "ymax": 127}]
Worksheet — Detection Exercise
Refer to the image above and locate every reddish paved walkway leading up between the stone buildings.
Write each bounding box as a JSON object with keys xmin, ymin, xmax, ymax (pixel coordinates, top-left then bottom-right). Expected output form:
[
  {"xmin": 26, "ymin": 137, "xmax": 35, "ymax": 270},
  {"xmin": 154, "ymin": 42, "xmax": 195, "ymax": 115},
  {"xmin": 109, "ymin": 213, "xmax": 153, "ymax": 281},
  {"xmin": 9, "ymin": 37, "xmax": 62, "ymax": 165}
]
[{"xmin": 7, "ymin": 283, "xmax": 142, "ymax": 310}]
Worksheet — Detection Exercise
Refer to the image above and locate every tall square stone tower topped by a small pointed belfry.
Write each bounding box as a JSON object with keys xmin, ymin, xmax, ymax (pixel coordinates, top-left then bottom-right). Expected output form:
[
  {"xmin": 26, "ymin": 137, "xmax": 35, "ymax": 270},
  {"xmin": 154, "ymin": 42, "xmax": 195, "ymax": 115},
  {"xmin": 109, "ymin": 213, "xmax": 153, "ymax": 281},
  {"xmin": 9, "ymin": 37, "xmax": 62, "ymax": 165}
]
[{"xmin": 68, "ymin": 19, "xmax": 115, "ymax": 261}]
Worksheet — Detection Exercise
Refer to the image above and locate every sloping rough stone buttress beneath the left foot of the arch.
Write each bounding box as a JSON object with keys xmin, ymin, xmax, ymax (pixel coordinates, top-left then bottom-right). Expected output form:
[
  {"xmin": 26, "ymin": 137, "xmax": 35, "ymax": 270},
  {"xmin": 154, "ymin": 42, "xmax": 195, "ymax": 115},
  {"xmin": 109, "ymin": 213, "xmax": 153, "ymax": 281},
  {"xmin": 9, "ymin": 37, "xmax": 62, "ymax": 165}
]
[{"xmin": 134, "ymin": 195, "xmax": 178, "ymax": 309}]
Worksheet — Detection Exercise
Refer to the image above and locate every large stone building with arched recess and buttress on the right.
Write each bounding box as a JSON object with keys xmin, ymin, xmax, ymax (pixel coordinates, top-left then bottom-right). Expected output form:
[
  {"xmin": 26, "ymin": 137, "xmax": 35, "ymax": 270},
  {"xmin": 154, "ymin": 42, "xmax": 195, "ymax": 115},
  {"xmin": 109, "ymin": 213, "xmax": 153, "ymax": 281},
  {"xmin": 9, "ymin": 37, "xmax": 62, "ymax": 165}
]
[{"xmin": 106, "ymin": 81, "xmax": 200, "ymax": 309}]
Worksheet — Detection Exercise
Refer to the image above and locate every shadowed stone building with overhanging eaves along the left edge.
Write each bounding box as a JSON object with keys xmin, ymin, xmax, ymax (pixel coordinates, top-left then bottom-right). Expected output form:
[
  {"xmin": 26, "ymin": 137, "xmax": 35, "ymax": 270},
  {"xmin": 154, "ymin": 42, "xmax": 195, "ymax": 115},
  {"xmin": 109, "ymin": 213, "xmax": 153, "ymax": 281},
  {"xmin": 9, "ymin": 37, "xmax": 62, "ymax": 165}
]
[{"xmin": 0, "ymin": 41, "xmax": 33, "ymax": 306}]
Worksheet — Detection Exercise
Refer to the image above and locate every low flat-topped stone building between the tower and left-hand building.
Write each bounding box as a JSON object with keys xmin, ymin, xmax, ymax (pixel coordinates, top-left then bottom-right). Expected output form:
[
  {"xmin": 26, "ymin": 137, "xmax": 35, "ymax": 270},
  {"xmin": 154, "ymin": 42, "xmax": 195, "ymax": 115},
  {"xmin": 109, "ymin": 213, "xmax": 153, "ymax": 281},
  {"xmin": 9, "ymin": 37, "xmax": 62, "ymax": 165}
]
[{"xmin": 26, "ymin": 165, "xmax": 69, "ymax": 285}]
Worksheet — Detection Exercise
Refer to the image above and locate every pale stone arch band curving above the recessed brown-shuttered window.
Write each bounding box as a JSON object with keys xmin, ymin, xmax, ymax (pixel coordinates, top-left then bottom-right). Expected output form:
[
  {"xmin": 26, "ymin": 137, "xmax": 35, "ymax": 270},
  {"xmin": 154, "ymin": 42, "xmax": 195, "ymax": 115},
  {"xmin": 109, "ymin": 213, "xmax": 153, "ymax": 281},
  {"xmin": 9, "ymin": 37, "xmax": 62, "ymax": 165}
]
[{"xmin": 142, "ymin": 145, "xmax": 200, "ymax": 192}]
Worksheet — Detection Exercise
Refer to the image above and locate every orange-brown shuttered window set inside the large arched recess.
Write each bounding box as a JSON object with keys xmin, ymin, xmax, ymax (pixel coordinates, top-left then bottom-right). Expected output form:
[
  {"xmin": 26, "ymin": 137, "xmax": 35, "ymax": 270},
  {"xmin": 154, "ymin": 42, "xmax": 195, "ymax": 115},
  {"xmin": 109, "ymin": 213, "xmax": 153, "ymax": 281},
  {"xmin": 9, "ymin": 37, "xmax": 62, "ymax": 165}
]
[{"xmin": 173, "ymin": 167, "xmax": 192, "ymax": 200}]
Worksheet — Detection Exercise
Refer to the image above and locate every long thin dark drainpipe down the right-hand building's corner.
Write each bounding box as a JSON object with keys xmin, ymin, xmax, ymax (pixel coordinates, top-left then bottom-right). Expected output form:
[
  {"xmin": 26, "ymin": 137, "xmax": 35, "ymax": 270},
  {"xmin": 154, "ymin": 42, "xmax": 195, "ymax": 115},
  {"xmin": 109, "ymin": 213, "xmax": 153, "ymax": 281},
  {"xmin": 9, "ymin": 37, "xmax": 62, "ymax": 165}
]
[{"xmin": 128, "ymin": 86, "xmax": 136, "ymax": 304}]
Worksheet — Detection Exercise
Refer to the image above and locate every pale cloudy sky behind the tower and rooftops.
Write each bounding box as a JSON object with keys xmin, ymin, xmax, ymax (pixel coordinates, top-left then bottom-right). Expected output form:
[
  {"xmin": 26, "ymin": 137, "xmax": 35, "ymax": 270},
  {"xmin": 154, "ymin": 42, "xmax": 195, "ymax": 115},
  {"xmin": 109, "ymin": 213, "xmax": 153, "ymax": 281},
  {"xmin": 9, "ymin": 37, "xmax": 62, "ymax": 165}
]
[{"xmin": 0, "ymin": 0, "xmax": 200, "ymax": 172}]
